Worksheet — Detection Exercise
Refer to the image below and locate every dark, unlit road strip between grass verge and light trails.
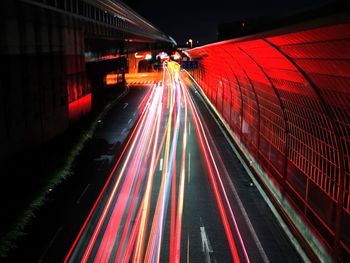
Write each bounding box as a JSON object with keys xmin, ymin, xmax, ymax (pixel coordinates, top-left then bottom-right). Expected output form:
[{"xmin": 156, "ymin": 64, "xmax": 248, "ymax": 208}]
[{"xmin": 4, "ymin": 84, "xmax": 151, "ymax": 263}]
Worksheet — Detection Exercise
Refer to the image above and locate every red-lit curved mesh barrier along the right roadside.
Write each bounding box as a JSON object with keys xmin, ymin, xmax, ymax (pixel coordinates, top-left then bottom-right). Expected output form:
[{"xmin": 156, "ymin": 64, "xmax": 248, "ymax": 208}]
[{"xmin": 188, "ymin": 9, "xmax": 350, "ymax": 262}]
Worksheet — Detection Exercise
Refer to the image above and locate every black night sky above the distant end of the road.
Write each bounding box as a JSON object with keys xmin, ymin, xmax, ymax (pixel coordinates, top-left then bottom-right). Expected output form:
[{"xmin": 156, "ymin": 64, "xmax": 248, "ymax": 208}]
[{"xmin": 123, "ymin": 0, "xmax": 334, "ymax": 45}]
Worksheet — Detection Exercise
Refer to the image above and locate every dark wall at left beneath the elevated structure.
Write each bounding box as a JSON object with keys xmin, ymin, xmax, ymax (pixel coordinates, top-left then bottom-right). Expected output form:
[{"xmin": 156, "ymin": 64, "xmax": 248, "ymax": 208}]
[{"xmin": 0, "ymin": 0, "xmax": 90, "ymax": 158}]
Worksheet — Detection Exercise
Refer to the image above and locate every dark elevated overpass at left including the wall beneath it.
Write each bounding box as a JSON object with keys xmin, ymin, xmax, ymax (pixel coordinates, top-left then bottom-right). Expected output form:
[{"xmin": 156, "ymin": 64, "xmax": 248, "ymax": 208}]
[{"xmin": 0, "ymin": 0, "xmax": 176, "ymax": 157}]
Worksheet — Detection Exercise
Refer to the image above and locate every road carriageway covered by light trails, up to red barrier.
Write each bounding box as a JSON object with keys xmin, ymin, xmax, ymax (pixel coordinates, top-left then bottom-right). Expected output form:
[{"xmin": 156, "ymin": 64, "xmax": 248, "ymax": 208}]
[{"xmin": 65, "ymin": 63, "xmax": 302, "ymax": 262}]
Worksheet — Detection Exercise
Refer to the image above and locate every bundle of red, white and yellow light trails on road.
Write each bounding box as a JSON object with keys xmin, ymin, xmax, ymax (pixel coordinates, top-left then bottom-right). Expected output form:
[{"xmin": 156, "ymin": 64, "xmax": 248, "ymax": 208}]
[{"xmin": 65, "ymin": 62, "xmax": 249, "ymax": 263}]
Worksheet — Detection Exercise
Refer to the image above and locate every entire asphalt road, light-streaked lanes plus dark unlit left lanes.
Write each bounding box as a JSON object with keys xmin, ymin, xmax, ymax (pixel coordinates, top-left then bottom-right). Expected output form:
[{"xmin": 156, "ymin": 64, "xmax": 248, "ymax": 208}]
[{"xmin": 7, "ymin": 63, "xmax": 303, "ymax": 263}]
